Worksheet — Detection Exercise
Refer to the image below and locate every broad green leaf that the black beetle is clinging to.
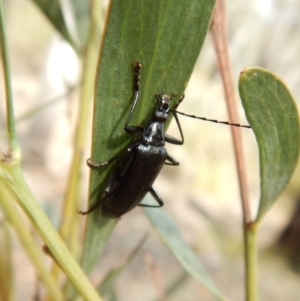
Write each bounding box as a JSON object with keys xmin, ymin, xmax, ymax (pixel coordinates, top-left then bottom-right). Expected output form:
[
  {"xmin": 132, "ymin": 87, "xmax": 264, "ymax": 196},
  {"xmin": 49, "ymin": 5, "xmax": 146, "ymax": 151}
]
[{"xmin": 83, "ymin": 0, "xmax": 215, "ymax": 269}]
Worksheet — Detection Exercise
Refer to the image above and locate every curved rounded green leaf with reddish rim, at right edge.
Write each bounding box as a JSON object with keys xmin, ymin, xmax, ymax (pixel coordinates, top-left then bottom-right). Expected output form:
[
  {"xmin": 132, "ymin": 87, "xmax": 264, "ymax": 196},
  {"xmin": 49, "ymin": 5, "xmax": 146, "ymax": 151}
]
[{"xmin": 239, "ymin": 67, "xmax": 299, "ymax": 219}]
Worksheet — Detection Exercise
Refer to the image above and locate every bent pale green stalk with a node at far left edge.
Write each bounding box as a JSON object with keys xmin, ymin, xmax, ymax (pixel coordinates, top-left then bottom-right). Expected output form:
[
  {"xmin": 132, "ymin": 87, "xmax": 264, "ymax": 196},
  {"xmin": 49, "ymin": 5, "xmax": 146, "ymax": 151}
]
[{"xmin": 0, "ymin": 1, "xmax": 101, "ymax": 301}]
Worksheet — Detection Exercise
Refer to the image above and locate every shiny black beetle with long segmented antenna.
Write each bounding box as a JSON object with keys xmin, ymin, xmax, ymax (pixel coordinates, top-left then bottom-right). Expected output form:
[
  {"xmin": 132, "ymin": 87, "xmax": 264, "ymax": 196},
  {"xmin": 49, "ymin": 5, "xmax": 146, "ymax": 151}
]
[{"xmin": 79, "ymin": 62, "xmax": 250, "ymax": 218}]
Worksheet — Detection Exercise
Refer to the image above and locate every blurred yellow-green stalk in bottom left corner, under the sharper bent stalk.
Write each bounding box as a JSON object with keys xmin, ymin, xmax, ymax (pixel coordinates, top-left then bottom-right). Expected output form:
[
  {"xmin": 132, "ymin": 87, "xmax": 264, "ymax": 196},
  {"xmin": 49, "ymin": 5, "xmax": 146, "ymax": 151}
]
[{"xmin": 0, "ymin": 186, "xmax": 64, "ymax": 301}]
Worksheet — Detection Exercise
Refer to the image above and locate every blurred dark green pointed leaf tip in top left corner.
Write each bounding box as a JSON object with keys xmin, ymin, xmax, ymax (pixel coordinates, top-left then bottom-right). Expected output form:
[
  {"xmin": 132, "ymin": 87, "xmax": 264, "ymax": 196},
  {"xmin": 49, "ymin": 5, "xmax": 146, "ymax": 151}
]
[{"xmin": 32, "ymin": 0, "xmax": 77, "ymax": 49}]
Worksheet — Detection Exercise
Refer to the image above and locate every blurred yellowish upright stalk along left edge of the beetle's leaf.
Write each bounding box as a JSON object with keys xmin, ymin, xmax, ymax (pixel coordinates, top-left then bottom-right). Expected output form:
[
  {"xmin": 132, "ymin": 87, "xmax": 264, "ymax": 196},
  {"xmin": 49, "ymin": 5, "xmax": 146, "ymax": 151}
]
[{"xmin": 59, "ymin": 0, "xmax": 102, "ymax": 254}]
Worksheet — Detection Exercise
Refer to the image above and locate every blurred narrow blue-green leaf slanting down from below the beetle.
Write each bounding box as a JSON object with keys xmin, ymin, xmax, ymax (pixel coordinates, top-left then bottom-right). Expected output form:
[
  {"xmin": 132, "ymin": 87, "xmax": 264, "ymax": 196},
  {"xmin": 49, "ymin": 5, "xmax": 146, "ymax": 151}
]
[{"xmin": 144, "ymin": 199, "xmax": 226, "ymax": 300}]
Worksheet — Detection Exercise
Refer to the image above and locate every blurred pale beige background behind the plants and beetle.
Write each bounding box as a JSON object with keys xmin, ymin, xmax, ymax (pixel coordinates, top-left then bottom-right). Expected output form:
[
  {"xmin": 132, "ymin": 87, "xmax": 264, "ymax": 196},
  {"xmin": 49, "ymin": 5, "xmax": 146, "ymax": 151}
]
[{"xmin": 0, "ymin": 0, "xmax": 300, "ymax": 301}]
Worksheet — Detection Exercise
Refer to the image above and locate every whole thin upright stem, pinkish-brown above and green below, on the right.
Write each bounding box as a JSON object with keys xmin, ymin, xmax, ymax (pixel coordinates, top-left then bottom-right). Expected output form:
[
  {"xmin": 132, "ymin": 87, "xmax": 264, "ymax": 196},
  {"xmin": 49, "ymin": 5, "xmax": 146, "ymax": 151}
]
[{"xmin": 210, "ymin": 0, "xmax": 257, "ymax": 301}]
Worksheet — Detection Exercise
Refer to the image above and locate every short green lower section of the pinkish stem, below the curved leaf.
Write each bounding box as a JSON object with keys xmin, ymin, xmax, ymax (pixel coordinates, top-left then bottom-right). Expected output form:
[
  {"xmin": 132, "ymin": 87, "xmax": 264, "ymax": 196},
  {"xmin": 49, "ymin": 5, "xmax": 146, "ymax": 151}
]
[{"xmin": 244, "ymin": 223, "xmax": 258, "ymax": 301}]
